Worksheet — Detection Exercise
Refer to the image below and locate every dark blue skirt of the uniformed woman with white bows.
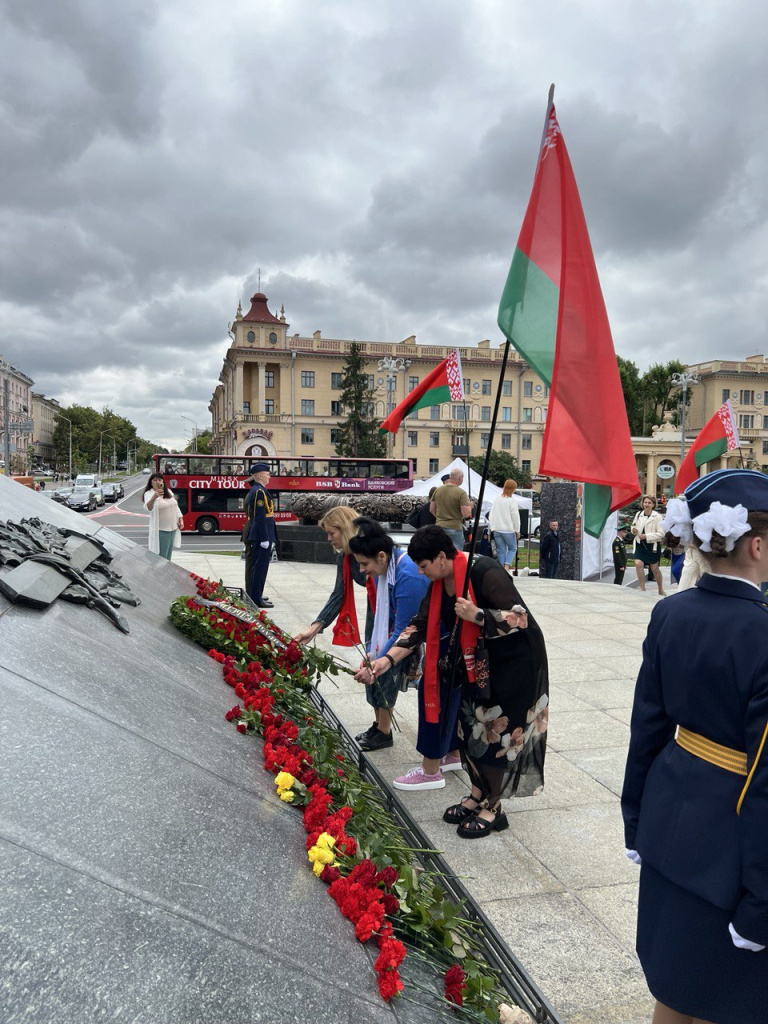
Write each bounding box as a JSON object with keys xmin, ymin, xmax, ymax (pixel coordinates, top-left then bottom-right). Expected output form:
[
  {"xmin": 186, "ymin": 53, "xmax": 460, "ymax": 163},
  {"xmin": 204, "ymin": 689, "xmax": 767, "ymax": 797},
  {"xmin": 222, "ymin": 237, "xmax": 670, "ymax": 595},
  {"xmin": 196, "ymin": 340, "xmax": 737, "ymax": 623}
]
[{"xmin": 637, "ymin": 864, "xmax": 768, "ymax": 1024}]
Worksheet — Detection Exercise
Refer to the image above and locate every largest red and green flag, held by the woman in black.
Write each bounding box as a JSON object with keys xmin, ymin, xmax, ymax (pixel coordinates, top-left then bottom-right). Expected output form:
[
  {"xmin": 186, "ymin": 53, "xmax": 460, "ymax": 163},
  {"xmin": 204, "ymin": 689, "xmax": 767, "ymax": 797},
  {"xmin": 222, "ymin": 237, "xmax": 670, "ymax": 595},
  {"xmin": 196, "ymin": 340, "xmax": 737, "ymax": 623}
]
[{"xmin": 499, "ymin": 93, "xmax": 640, "ymax": 537}]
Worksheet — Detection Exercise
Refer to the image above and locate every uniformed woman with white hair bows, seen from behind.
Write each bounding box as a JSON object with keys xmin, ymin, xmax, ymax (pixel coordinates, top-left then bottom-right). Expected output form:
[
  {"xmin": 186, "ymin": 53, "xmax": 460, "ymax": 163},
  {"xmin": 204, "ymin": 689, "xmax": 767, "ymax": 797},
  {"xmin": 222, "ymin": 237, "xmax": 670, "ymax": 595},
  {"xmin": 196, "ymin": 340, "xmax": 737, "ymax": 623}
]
[{"xmin": 622, "ymin": 469, "xmax": 768, "ymax": 1024}]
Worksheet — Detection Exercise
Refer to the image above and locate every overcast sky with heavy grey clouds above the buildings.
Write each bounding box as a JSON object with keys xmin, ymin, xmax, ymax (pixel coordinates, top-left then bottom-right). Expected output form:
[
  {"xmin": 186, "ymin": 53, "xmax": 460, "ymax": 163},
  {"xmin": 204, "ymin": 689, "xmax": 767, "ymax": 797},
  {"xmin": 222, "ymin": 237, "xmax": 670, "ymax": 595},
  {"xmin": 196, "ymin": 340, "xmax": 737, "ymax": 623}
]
[{"xmin": 0, "ymin": 0, "xmax": 768, "ymax": 445}]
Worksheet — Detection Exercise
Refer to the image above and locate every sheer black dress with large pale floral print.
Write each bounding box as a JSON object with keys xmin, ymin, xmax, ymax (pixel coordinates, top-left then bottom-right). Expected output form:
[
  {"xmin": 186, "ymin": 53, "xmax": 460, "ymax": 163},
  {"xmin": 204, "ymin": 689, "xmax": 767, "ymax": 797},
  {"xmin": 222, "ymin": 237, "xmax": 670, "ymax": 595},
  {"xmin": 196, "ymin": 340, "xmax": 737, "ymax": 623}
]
[{"xmin": 396, "ymin": 557, "xmax": 549, "ymax": 807}]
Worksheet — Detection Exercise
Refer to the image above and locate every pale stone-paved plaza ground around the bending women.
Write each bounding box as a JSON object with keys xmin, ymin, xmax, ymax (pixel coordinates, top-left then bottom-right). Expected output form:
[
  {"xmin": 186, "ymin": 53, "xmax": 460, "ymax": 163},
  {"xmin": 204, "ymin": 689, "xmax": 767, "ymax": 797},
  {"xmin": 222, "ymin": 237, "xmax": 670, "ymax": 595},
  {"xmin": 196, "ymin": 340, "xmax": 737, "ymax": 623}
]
[{"xmin": 174, "ymin": 550, "xmax": 659, "ymax": 1024}]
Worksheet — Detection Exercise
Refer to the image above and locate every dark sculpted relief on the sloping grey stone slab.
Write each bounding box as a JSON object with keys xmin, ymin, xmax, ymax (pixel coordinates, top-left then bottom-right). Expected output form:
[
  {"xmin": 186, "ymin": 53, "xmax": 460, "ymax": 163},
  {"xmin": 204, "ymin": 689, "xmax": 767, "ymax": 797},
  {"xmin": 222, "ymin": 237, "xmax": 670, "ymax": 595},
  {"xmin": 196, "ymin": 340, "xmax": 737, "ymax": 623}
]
[{"xmin": 0, "ymin": 518, "xmax": 140, "ymax": 633}]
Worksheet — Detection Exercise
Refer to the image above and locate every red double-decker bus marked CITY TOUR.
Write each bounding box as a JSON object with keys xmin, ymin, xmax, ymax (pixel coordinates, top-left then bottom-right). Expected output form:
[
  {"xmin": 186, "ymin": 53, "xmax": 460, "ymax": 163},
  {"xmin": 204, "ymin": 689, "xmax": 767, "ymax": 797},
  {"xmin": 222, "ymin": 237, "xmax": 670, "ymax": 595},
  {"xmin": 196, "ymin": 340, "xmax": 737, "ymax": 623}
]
[{"xmin": 153, "ymin": 455, "xmax": 413, "ymax": 534}]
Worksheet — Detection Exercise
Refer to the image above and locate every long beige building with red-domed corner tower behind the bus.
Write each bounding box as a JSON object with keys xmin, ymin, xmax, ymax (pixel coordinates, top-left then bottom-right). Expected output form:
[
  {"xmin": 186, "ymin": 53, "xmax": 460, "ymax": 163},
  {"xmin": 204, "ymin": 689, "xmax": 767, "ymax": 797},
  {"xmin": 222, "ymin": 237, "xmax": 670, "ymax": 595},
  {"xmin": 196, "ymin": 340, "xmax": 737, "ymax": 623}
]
[{"xmin": 209, "ymin": 293, "xmax": 549, "ymax": 477}]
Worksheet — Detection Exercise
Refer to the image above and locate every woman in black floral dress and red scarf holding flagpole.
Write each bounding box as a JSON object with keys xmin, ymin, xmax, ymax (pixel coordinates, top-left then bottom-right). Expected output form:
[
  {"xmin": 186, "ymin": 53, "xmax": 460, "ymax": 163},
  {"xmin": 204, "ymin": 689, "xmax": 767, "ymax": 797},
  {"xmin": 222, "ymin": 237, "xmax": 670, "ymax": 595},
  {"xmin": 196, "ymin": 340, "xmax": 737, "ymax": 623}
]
[{"xmin": 364, "ymin": 526, "xmax": 549, "ymax": 839}]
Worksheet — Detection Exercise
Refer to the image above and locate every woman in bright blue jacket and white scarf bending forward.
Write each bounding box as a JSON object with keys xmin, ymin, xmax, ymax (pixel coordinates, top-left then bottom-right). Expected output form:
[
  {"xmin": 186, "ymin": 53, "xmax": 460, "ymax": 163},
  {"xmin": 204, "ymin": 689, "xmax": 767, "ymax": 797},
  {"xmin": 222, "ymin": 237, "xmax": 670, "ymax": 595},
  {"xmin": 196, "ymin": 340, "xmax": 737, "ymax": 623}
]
[{"xmin": 349, "ymin": 516, "xmax": 427, "ymax": 751}]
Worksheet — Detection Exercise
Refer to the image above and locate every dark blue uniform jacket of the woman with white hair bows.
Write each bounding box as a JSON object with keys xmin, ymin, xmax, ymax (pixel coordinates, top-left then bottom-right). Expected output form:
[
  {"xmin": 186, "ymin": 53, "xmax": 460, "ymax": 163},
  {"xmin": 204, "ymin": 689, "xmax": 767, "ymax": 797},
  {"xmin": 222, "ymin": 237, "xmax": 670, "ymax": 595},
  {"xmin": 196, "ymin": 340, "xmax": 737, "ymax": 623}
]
[{"xmin": 622, "ymin": 574, "xmax": 768, "ymax": 945}]
